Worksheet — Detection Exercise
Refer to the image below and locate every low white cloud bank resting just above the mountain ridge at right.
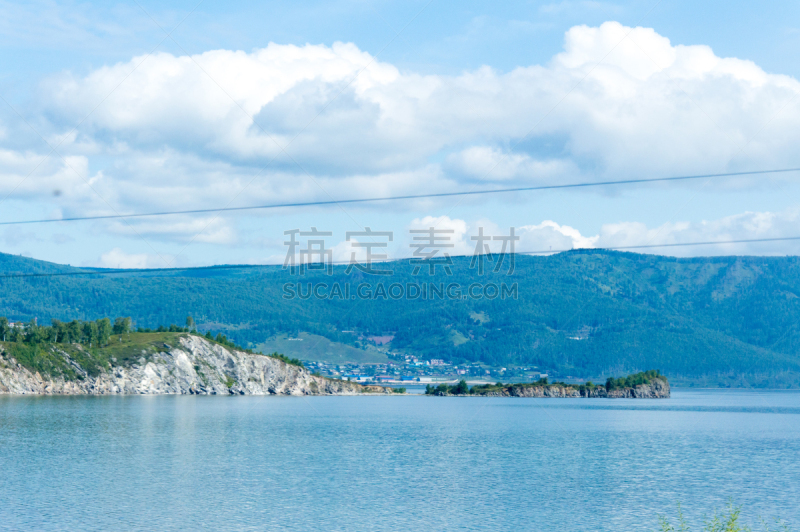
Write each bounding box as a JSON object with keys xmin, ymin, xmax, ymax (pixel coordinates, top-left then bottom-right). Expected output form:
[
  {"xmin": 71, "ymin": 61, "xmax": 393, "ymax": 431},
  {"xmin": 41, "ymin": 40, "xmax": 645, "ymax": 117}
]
[{"xmin": 248, "ymin": 208, "xmax": 800, "ymax": 264}]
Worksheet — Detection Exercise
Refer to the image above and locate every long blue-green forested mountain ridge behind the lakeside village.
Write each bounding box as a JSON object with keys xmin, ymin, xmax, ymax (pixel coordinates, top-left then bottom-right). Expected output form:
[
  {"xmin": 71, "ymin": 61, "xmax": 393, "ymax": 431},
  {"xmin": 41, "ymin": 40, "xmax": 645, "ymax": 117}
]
[{"xmin": 0, "ymin": 250, "xmax": 800, "ymax": 377}]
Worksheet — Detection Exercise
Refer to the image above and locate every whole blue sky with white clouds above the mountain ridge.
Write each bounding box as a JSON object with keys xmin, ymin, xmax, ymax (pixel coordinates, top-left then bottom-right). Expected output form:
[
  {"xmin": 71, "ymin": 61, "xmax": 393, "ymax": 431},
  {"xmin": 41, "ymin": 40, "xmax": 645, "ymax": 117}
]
[{"xmin": 0, "ymin": 0, "xmax": 800, "ymax": 268}]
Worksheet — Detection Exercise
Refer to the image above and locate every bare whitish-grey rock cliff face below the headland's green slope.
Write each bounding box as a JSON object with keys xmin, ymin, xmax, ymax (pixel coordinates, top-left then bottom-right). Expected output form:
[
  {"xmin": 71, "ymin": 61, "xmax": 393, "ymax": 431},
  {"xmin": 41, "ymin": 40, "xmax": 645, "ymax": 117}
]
[{"xmin": 0, "ymin": 336, "xmax": 392, "ymax": 395}]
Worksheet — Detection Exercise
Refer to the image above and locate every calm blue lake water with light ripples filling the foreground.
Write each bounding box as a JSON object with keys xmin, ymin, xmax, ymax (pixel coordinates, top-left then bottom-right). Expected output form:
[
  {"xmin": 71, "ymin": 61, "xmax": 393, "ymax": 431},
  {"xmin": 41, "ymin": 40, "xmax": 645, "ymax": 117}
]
[{"xmin": 0, "ymin": 391, "xmax": 800, "ymax": 532}]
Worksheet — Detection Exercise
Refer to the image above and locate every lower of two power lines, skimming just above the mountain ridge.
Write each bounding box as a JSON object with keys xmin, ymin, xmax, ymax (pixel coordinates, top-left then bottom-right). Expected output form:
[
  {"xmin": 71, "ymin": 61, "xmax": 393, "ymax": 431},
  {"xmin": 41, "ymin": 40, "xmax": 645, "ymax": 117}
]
[{"xmin": 0, "ymin": 236, "xmax": 800, "ymax": 279}]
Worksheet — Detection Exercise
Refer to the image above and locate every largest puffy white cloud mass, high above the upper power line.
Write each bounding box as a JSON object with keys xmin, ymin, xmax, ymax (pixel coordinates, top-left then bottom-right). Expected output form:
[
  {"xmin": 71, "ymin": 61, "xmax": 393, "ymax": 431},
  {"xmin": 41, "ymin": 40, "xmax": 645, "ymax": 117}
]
[{"xmin": 44, "ymin": 22, "xmax": 800, "ymax": 181}]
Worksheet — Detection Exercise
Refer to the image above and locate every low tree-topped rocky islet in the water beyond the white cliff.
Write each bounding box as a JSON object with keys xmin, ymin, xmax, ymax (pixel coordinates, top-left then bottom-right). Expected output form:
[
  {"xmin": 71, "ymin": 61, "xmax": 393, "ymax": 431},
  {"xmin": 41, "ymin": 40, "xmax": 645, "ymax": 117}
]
[{"xmin": 425, "ymin": 370, "xmax": 670, "ymax": 399}]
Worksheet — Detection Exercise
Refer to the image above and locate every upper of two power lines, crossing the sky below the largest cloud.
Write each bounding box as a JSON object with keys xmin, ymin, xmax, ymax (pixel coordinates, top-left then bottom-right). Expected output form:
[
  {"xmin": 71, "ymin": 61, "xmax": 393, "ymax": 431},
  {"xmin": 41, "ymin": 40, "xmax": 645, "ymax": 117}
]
[{"xmin": 0, "ymin": 168, "xmax": 800, "ymax": 225}]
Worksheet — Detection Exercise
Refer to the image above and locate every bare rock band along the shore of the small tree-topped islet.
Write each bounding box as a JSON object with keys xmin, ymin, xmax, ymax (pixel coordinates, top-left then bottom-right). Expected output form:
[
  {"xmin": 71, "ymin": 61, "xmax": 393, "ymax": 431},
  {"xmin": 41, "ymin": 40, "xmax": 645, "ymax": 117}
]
[{"xmin": 472, "ymin": 379, "xmax": 670, "ymax": 399}]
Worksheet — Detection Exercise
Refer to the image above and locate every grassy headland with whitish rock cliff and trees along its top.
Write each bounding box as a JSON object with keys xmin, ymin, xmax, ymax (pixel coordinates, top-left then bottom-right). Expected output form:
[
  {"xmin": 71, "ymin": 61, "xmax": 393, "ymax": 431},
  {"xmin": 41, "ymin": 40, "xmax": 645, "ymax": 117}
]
[{"xmin": 0, "ymin": 330, "xmax": 394, "ymax": 395}]
